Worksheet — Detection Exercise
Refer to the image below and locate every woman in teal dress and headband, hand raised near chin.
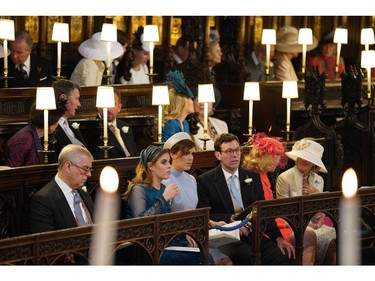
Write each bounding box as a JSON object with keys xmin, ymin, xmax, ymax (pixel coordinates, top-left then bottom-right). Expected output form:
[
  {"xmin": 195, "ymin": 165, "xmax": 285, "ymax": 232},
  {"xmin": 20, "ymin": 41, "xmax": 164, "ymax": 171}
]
[{"xmin": 124, "ymin": 145, "xmax": 210, "ymax": 265}]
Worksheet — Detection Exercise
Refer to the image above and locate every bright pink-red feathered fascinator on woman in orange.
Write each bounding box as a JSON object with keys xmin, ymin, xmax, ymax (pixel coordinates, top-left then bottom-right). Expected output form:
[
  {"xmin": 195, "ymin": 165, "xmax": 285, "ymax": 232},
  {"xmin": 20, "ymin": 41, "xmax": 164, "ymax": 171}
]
[{"xmin": 249, "ymin": 133, "xmax": 288, "ymax": 168}]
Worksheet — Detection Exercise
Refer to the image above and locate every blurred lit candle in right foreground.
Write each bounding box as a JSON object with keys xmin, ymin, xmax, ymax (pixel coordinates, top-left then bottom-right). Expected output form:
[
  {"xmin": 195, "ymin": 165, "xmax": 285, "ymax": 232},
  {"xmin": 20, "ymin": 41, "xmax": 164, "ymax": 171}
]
[{"xmin": 338, "ymin": 168, "xmax": 360, "ymax": 265}]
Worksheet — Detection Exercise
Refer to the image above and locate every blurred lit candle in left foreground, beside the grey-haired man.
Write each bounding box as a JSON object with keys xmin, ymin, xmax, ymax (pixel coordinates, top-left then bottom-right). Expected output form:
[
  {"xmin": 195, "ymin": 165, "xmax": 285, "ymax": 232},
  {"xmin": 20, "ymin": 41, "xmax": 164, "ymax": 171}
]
[{"xmin": 89, "ymin": 166, "xmax": 120, "ymax": 265}]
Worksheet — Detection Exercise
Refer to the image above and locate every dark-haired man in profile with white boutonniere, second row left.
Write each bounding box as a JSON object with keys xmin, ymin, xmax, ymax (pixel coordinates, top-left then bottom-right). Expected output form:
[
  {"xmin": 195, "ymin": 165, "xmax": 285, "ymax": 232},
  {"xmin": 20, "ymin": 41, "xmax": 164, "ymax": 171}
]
[{"xmin": 52, "ymin": 79, "xmax": 87, "ymax": 155}]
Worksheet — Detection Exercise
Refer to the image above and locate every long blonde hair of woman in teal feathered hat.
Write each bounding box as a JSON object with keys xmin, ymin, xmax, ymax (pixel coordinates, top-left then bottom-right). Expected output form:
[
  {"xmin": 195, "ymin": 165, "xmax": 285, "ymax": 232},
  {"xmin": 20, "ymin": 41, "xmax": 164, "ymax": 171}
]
[{"xmin": 163, "ymin": 88, "xmax": 189, "ymax": 125}]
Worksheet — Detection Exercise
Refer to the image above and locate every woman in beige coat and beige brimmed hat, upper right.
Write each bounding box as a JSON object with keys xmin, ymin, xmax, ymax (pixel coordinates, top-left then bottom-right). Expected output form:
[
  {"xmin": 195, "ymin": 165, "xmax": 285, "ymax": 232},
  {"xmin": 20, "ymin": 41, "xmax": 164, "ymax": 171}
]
[{"xmin": 275, "ymin": 25, "xmax": 318, "ymax": 81}]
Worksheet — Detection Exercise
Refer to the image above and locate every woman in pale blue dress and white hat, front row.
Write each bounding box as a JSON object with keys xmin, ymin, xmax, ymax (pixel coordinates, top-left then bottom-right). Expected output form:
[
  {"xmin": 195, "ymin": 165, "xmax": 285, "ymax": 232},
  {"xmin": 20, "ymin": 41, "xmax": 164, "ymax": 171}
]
[{"xmin": 162, "ymin": 132, "xmax": 232, "ymax": 265}]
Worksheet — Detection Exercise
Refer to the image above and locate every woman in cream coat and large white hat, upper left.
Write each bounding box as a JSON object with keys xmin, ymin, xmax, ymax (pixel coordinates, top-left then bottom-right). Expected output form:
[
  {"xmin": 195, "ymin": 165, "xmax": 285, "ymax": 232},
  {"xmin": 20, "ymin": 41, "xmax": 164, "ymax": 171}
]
[{"xmin": 70, "ymin": 32, "xmax": 124, "ymax": 86}]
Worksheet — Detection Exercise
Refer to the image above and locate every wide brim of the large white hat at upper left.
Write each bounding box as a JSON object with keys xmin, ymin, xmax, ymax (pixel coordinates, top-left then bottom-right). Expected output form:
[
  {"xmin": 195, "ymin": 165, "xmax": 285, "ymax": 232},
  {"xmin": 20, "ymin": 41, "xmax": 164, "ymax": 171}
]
[{"xmin": 78, "ymin": 38, "xmax": 124, "ymax": 61}]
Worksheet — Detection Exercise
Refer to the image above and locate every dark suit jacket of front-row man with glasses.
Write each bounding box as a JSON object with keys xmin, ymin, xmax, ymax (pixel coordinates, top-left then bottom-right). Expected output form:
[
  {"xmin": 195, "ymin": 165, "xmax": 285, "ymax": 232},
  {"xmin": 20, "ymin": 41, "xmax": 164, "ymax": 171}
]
[{"xmin": 197, "ymin": 165, "xmax": 282, "ymax": 241}]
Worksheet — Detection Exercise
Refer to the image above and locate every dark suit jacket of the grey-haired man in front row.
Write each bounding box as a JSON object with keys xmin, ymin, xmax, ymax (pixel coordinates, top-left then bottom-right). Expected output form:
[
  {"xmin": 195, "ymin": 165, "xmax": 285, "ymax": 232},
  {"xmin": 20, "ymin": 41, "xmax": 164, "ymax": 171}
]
[{"xmin": 30, "ymin": 179, "xmax": 94, "ymax": 233}]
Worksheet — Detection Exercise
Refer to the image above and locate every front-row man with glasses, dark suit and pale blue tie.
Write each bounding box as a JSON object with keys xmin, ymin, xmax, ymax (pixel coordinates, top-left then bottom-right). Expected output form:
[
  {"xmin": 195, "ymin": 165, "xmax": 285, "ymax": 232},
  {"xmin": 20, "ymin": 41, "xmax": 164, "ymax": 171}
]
[{"xmin": 197, "ymin": 134, "xmax": 295, "ymax": 265}]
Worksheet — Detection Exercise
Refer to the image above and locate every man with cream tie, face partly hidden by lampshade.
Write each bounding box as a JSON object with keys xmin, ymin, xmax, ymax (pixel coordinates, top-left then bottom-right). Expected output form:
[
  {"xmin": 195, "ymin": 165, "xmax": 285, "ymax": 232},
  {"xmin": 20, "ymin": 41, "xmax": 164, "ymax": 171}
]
[{"xmin": 86, "ymin": 90, "xmax": 139, "ymax": 159}]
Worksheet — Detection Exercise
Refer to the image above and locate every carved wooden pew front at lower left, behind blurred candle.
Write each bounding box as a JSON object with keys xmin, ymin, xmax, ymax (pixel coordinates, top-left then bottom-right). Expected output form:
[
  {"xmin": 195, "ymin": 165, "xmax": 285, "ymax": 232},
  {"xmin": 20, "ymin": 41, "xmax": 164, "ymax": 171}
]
[{"xmin": 0, "ymin": 208, "xmax": 209, "ymax": 265}]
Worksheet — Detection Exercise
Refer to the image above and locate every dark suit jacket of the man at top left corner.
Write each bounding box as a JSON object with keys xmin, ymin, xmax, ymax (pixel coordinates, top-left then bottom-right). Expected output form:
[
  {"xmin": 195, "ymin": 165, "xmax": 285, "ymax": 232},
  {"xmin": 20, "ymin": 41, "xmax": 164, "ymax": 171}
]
[{"xmin": 0, "ymin": 54, "xmax": 53, "ymax": 88}]
